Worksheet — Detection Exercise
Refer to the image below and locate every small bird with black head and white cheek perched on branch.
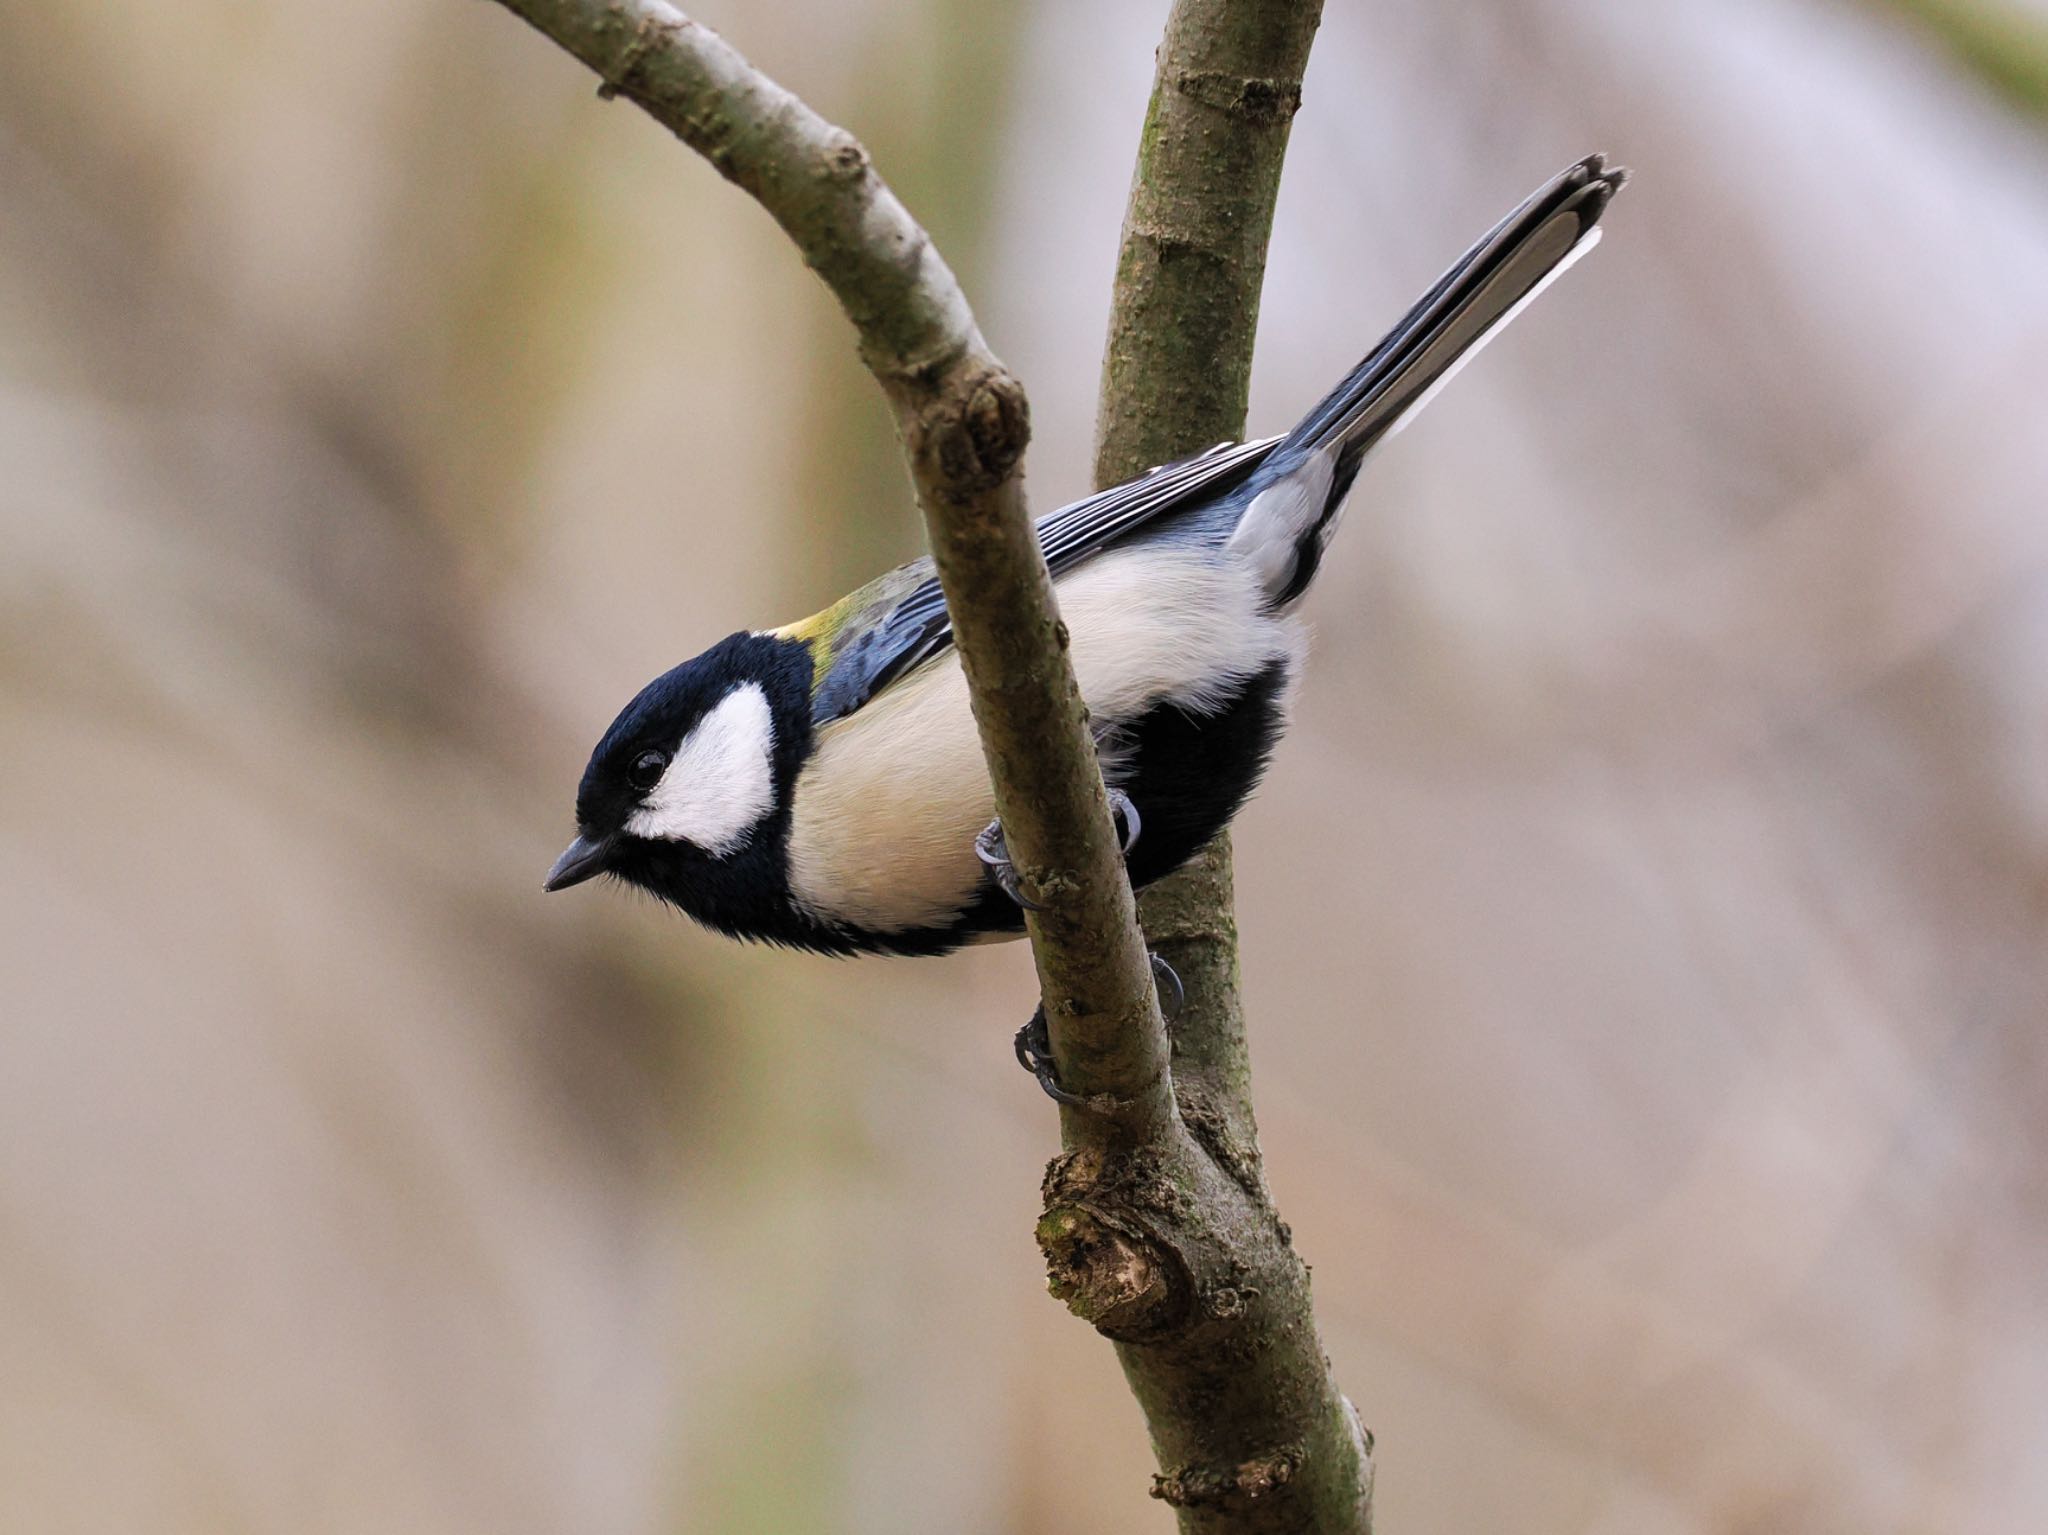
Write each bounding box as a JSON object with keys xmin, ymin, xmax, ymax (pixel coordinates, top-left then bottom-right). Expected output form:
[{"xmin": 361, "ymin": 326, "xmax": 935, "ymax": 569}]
[{"xmin": 547, "ymin": 156, "xmax": 1624, "ymax": 974}]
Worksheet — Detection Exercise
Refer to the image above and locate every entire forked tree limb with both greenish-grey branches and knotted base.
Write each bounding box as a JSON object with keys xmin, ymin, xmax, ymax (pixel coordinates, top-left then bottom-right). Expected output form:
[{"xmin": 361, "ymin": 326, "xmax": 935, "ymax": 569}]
[{"xmin": 483, "ymin": 0, "xmax": 1370, "ymax": 1533}]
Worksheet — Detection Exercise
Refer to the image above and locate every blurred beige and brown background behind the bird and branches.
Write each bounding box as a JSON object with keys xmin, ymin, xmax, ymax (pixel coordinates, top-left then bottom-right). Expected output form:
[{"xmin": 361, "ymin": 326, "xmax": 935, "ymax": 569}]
[{"xmin": 0, "ymin": 0, "xmax": 2048, "ymax": 1535}]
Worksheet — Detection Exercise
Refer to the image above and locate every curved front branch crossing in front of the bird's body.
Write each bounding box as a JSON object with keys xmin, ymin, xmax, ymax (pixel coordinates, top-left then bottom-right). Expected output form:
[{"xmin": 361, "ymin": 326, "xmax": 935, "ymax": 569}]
[{"xmin": 483, "ymin": 0, "xmax": 1171, "ymax": 1138}]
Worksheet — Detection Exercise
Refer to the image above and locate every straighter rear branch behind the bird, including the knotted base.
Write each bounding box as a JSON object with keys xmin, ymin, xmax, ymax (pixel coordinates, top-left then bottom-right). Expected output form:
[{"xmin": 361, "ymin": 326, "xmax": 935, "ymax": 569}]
[{"xmin": 1040, "ymin": 0, "xmax": 1372, "ymax": 1535}]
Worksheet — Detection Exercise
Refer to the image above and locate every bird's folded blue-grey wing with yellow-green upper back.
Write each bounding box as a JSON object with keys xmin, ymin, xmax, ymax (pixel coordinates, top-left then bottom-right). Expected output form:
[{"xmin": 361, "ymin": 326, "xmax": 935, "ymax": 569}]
[{"xmin": 776, "ymin": 438, "xmax": 1280, "ymax": 725}]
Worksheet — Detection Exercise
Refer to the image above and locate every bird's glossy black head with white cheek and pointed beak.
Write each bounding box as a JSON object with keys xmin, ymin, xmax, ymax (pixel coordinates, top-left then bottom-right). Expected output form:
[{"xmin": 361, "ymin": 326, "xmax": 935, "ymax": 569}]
[{"xmin": 547, "ymin": 634, "xmax": 811, "ymax": 907}]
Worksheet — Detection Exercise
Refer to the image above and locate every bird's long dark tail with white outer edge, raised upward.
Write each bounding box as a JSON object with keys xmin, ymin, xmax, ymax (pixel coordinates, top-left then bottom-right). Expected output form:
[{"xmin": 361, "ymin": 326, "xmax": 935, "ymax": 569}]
[{"xmin": 1231, "ymin": 156, "xmax": 1628, "ymax": 608}]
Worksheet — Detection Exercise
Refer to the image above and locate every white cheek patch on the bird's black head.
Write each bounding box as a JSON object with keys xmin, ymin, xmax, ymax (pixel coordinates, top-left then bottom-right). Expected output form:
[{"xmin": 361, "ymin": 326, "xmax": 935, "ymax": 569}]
[{"xmin": 627, "ymin": 682, "xmax": 774, "ymax": 858}]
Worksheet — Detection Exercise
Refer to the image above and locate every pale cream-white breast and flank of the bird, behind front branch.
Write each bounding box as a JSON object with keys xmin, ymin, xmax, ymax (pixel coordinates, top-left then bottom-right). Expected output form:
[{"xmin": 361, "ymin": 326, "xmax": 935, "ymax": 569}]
[{"xmin": 791, "ymin": 549, "xmax": 1298, "ymax": 931}]
